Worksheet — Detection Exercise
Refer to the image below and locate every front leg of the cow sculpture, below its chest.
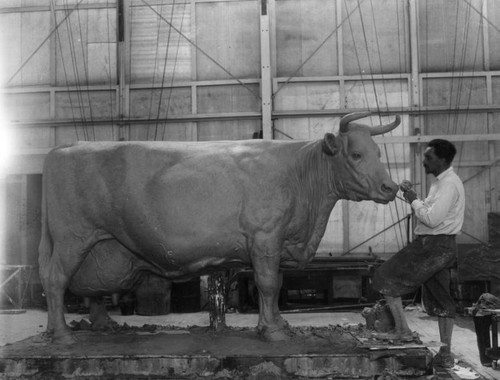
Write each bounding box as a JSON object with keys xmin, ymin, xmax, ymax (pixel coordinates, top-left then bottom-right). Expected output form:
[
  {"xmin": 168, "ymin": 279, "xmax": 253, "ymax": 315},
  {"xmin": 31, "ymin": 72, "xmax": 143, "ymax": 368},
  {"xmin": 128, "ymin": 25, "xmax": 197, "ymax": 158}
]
[{"xmin": 252, "ymin": 241, "xmax": 289, "ymax": 341}]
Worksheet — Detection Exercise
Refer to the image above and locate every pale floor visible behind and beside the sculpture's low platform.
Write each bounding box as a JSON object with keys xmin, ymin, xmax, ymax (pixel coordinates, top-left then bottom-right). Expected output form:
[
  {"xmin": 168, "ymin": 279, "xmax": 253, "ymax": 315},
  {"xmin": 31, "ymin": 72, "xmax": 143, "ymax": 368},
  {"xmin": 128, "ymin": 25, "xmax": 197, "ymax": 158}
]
[{"xmin": 0, "ymin": 307, "xmax": 500, "ymax": 380}]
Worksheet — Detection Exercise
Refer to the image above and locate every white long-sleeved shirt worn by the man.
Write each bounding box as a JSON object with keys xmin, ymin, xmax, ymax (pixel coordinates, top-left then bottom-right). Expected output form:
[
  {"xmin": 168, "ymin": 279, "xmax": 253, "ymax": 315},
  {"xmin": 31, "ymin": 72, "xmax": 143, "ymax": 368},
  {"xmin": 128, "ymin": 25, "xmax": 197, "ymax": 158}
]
[{"xmin": 411, "ymin": 167, "xmax": 465, "ymax": 235}]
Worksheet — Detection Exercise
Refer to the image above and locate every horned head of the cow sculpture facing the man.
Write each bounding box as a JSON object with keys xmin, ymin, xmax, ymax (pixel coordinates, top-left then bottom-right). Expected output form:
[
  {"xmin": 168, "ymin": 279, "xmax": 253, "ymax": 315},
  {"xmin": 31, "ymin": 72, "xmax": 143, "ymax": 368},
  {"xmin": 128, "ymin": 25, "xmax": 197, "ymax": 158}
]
[{"xmin": 323, "ymin": 112, "xmax": 401, "ymax": 203}]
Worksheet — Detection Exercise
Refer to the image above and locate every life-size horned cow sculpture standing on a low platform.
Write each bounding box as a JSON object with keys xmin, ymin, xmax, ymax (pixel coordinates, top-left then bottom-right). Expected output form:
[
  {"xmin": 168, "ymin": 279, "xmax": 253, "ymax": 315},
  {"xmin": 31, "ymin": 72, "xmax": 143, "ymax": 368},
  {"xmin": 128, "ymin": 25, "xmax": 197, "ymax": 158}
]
[{"xmin": 39, "ymin": 113, "xmax": 400, "ymax": 343}]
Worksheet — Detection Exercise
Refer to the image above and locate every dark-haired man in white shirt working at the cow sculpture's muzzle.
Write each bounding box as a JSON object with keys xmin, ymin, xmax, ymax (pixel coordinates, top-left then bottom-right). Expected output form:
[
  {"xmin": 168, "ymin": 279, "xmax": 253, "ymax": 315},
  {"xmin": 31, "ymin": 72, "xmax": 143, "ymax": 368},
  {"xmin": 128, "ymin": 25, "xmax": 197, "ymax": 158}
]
[{"xmin": 373, "ymin": 139, "xmax": 465, "ymax": 367}]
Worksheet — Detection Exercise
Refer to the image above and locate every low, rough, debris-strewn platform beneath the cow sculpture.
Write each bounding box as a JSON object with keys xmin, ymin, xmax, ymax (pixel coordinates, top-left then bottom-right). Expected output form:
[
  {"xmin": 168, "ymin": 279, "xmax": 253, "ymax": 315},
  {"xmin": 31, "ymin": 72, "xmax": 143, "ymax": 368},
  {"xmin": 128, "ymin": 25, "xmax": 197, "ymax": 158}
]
[{"xmin": 0, "ymin": 326, "xmax": 432, "ymax": 379}]
